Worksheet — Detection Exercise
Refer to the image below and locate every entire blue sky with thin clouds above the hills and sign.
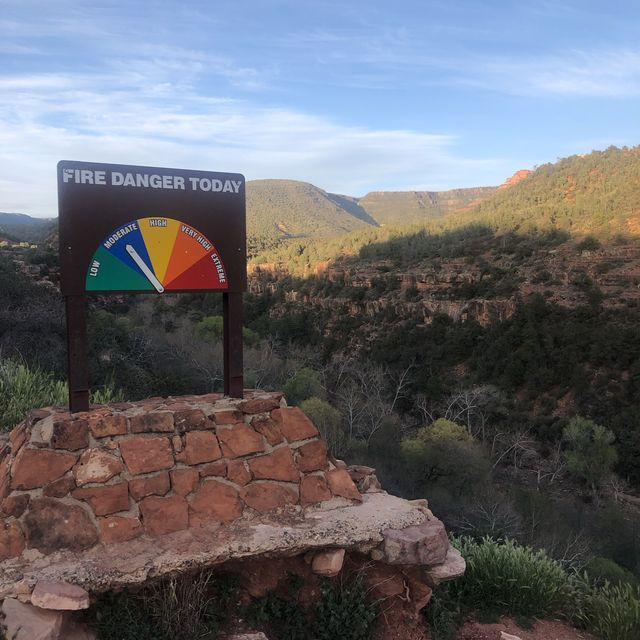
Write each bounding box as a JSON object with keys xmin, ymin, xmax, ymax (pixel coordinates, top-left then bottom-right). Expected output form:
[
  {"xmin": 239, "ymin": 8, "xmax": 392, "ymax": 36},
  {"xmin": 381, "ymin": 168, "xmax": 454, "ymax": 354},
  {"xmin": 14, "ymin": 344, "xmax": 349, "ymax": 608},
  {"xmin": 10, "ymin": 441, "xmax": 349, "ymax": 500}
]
[{"xmin": 0, "ymin": 0, "xmax": 640, "ymax": 216}]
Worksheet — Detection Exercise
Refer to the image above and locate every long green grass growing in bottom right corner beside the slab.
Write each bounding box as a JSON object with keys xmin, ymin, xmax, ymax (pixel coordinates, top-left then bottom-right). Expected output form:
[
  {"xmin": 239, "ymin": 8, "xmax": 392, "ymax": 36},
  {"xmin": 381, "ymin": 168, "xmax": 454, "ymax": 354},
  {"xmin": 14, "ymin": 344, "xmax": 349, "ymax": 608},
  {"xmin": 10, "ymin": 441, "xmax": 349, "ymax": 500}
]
[{"xmin": 425, "ymin": 538, "xmax": 640, "ymax": 640}]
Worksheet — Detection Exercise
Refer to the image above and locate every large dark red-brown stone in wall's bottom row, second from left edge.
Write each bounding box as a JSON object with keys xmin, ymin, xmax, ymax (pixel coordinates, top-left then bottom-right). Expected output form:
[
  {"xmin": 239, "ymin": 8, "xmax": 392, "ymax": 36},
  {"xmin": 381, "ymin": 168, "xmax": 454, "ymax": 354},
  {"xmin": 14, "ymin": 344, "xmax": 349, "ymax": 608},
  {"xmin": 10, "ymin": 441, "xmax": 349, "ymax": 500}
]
[{"xmin": 24, "ymin": 498, "xmax": 98, "ymax": 555}]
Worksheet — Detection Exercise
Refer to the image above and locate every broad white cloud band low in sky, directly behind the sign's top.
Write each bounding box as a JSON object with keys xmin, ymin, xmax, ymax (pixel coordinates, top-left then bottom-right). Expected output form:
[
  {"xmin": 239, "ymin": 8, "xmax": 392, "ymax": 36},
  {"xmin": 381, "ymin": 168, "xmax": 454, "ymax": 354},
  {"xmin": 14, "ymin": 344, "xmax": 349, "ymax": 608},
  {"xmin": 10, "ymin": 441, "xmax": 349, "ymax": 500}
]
[{"xmin": 0, "ymin": 65, "xmax": 507, "ymax": 215}]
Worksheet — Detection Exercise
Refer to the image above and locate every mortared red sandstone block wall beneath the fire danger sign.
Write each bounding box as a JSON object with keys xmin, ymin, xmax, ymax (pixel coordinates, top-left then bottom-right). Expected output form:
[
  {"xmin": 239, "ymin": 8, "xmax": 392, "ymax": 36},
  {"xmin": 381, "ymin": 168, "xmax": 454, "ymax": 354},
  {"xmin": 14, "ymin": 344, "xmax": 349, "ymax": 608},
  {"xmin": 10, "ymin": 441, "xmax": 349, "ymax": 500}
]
[{"xmin": 0, "ymin": 392, "xmax": 361, "ymax": 561}]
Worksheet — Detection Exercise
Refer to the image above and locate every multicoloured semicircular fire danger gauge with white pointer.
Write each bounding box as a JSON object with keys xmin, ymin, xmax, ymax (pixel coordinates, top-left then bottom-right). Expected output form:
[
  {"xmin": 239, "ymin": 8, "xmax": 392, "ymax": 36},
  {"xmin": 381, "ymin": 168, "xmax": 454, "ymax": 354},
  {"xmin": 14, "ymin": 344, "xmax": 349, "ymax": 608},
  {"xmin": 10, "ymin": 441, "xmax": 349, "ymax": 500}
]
[{"xmin": 85, "ymin": 217, "xmax": 228, "ymax": 293}]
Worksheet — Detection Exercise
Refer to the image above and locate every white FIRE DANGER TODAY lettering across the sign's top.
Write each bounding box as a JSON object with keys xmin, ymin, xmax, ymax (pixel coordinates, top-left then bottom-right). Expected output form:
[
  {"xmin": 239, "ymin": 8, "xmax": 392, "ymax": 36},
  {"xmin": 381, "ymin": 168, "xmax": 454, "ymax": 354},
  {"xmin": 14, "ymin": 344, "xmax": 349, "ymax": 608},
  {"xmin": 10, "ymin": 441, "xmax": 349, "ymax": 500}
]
[{"xmin": 62, "ymin": 168, "xmax": 242, "ymax": 193}]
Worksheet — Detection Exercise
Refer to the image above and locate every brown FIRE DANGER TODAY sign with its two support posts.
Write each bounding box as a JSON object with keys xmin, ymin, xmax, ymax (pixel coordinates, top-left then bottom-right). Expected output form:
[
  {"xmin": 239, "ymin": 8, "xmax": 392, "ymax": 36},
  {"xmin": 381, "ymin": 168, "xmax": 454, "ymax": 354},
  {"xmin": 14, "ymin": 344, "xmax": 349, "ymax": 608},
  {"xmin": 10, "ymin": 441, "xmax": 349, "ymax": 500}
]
[{"xmin": 58, "ymin": 161, "xmax": 247, "ymax": 411}]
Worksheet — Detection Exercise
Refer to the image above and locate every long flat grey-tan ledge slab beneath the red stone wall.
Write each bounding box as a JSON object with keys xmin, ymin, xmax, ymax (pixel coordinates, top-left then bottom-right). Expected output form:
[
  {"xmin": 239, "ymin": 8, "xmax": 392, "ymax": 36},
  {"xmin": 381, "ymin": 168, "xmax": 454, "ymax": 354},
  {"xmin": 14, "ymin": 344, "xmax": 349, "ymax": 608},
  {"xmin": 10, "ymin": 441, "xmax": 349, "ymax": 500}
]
[{"xmin": 0, "ymin": 493, "xmax": 428, "ymax": 599}]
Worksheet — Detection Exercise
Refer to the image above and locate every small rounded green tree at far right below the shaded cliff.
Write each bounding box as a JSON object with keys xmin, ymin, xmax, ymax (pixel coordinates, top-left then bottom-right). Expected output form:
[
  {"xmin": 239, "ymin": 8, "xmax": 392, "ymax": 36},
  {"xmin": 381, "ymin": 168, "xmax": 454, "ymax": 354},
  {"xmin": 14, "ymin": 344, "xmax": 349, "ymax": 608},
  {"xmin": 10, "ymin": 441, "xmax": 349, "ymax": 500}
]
[{"xmin": 562, "ymin": 416, "xmax": 618, "ymax": 495}]
